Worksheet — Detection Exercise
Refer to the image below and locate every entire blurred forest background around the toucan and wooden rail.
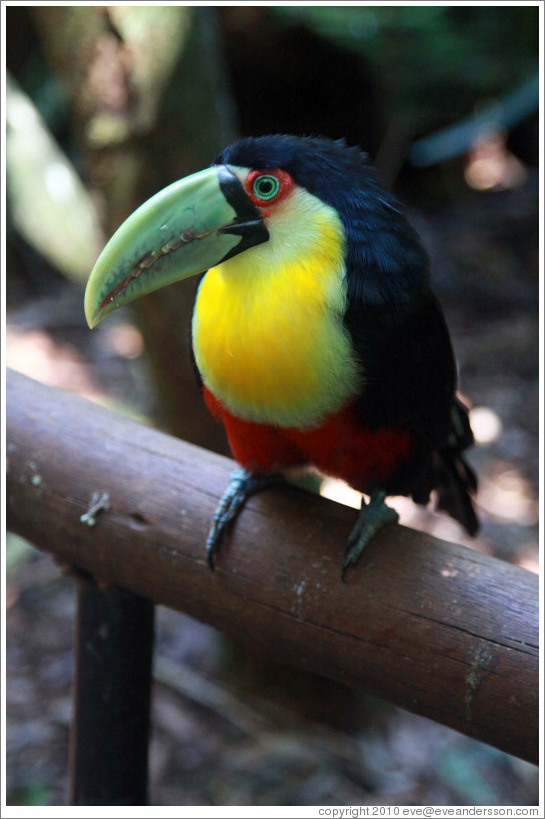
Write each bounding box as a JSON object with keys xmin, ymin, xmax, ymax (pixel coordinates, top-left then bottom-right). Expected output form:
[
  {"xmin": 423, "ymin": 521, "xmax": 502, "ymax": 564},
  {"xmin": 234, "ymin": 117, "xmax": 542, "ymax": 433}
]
[{"xmin": 5, "ymin": 3, "xmax": 540, "ymax": 804}]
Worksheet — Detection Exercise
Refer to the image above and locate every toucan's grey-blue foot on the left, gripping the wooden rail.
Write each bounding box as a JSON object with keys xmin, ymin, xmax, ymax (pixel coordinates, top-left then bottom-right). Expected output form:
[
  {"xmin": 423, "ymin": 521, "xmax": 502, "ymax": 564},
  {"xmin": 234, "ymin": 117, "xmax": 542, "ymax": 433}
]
[{"xmin": 206, "ymin": 468, "xmax": 285, "ymax": 569}]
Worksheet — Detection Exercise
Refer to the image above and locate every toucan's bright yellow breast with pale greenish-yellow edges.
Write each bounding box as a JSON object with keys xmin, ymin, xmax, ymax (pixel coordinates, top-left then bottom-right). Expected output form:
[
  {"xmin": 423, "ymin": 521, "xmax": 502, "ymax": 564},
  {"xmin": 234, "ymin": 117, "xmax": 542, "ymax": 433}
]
[{"xmin": 193, "ymin": 190, "xmax": 360, "ymax": 428}]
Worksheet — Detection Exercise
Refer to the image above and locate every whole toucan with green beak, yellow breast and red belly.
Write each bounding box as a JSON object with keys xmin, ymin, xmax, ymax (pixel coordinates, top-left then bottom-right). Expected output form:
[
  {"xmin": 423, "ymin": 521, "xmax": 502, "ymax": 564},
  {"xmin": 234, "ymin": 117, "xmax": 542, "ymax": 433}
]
[{"xmin": 85, "ymin": 134, "xmax": 478, "ymax": 577}]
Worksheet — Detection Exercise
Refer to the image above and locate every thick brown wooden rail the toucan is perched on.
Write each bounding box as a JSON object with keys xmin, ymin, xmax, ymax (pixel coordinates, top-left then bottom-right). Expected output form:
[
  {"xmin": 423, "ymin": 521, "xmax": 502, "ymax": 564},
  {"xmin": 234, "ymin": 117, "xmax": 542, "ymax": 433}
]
[{"xmin": 7, "ymin": 373, "xmax": 538, "ymax": 763}]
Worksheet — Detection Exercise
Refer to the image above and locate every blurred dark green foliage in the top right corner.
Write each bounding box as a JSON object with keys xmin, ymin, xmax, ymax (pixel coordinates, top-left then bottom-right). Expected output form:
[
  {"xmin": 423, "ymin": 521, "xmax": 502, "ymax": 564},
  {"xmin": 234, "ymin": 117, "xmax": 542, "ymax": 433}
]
[{"xmin": 279, "ymin": 4, "xmax": 538, "ymax": 125}]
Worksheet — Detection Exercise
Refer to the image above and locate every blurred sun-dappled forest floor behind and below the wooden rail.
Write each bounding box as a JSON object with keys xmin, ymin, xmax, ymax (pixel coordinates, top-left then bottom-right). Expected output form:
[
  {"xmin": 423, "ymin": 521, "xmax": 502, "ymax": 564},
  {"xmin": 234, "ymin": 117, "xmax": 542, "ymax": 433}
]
[{"xmin": 6, "ymin": 173, "xmax": 539, "ymax": 806}]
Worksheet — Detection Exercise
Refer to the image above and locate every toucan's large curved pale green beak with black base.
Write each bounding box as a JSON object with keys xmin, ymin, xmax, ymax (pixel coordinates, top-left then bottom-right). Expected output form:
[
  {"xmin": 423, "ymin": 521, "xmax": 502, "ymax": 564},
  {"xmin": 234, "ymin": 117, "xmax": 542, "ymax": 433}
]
[{"xmin": 85, "ymin": 165, "xmax": 269, "ymax": 327}]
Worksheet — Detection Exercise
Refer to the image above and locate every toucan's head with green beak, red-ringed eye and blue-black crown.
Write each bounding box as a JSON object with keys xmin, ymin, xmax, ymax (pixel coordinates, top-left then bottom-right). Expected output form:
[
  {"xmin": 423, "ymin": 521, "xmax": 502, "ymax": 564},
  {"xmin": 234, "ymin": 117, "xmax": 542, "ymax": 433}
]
[{"xmin": 85, "ymin": 135, "xmax": 426, "ymax": 327}]
